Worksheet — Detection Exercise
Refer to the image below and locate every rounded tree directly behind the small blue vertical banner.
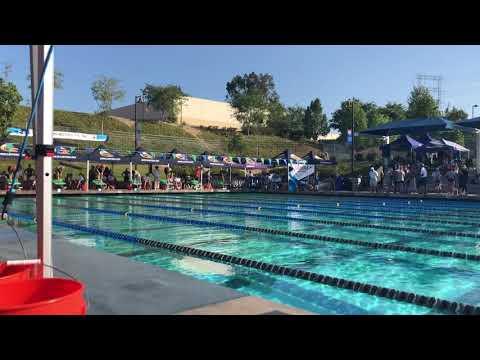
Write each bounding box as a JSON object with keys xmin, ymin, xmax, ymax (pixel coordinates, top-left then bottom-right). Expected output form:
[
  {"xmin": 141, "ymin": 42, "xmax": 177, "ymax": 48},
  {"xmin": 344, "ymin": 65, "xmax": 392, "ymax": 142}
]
[{"xmin": 330, "ymin": 98, "xmax": 368, "ymax": 141}]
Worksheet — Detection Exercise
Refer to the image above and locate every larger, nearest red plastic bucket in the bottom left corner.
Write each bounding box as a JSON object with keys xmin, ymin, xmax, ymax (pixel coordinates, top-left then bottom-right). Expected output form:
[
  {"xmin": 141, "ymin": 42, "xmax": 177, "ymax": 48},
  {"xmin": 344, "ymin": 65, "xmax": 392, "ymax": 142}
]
[{"xmin": 0, "ymin": 278, "xmax": 87, "ymax": 315}]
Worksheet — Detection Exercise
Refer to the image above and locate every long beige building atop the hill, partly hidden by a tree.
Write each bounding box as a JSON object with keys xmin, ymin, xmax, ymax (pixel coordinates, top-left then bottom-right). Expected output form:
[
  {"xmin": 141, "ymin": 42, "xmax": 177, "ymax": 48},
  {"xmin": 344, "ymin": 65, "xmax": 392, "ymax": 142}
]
[{"xmin": 109, "ymin": 96, "xmax": 241, "ymax": 129}]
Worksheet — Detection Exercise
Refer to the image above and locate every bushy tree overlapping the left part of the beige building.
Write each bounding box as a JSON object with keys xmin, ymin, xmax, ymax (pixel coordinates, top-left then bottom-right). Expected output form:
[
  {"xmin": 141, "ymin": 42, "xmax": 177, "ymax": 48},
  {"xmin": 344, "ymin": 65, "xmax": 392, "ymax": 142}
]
[{"xmin": 143, "ymin": 84, "xmax": 187, "ymax": 122}]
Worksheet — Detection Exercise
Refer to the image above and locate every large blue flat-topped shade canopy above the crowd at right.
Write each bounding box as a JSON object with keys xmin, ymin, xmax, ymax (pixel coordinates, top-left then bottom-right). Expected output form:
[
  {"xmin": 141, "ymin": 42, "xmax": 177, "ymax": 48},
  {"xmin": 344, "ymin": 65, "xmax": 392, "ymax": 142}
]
[{"xmin": 360, "ymin": 117, "xmax": 471, "ymax": 136}]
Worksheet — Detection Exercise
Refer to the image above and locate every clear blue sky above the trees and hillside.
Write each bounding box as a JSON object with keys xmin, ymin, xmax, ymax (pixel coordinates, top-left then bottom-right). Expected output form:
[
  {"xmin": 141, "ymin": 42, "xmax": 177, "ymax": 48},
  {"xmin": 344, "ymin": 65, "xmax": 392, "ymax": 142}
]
[{"xmin": 0, "ymin": 45, "xmax": 480, "ymax": 117}]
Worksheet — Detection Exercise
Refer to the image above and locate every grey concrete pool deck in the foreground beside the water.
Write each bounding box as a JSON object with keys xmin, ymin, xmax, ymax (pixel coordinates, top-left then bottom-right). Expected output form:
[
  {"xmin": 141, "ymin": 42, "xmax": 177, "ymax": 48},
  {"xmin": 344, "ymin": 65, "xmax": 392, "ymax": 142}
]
[{"xmin": 0, "ymin": 223, "xmax": 309, "ymax": 315}]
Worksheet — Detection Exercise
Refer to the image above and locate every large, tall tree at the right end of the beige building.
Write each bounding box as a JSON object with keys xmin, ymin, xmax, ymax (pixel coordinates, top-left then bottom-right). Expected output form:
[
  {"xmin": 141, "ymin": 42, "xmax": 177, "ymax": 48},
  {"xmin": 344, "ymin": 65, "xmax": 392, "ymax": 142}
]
[{"xmin": 226, "ymin": 72, "xmax": 279, "ymax": 135}]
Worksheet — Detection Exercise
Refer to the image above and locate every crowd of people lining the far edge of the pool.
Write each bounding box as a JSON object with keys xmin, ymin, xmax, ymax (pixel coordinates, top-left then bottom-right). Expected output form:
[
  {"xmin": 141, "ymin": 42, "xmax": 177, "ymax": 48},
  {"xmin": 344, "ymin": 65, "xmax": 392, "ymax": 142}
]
[{"xmin": 0, "ymin": 160, "xmax": 480, "ymax": 195}]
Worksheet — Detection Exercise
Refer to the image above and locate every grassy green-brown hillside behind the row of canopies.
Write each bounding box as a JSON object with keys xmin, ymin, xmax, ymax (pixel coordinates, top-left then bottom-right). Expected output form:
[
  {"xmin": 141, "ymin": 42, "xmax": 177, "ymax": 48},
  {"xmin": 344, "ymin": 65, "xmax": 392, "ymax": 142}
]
[{"xmin": 12, "ymin": 107, "xmax": 326, "ymax": 157}]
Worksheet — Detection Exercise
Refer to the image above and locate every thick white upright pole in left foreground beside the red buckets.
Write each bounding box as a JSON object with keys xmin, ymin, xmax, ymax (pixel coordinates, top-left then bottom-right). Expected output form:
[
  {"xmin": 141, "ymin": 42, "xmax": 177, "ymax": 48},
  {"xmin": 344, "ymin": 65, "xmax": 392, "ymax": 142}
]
[{"xmin": 30, "ymin": 45, "xmax": 54, "ymax": 277}]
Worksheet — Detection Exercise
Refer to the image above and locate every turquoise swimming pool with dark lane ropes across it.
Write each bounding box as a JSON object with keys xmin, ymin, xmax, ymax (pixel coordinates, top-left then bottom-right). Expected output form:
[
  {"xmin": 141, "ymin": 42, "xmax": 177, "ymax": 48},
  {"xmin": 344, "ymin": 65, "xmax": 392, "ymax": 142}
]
[{"xmin": 6, "ymin": 193, "xmax": 480, "ymax": 314}]
